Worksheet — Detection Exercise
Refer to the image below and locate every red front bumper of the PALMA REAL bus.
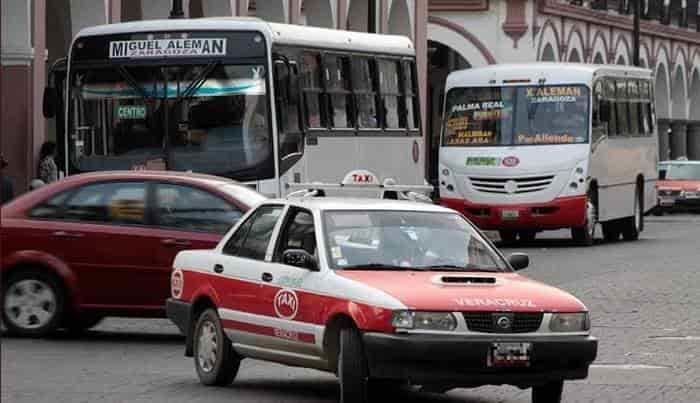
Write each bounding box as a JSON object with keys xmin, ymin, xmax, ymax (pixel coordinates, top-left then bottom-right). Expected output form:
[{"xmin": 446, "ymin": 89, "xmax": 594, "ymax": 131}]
[{"xmin": 440, "ymin": 195, "xmax": 586, "ymax": 230}]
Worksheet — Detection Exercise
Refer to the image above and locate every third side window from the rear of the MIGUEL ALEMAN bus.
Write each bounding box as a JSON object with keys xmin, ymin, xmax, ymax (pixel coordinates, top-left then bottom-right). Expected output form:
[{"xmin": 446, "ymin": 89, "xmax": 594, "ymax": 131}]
[{"xmin": 352, "ymin": 57, "xmax": 381, "ymax": 129}]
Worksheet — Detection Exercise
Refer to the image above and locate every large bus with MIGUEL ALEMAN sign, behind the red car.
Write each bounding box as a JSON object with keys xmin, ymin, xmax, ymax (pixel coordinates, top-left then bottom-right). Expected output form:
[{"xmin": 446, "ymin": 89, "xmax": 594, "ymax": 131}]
[{"xmin": 44, "ymin": 17, "xmax": 429, "ymax": 197}]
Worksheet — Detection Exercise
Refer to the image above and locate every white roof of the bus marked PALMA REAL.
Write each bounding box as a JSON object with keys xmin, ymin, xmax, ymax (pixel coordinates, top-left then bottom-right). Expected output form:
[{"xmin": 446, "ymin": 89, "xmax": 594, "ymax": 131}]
[{"xmin": 446, "ymin": 62, "xmax": 652, "ymax": 90}]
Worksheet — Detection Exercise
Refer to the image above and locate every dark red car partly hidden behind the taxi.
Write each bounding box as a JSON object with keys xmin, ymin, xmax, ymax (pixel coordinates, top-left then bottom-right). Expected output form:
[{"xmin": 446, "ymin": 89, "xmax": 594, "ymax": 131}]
[{"xmin": 0, "ymin": 171, "xmax": 265, "ymax": 335}]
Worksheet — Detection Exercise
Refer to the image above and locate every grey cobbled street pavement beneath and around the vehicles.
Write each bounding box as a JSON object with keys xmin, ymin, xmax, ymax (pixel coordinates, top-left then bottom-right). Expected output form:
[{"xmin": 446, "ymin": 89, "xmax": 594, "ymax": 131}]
[{"xmin": 0, "ymin": 215, "xmax": 700, "ymax": 403}]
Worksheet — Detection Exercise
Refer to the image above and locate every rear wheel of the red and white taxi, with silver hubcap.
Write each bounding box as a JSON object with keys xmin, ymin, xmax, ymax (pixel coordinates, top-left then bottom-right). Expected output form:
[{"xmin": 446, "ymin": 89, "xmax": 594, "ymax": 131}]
[{"xmin": 194, "ymin": 308, "xmax": 241, "ymax": 386}]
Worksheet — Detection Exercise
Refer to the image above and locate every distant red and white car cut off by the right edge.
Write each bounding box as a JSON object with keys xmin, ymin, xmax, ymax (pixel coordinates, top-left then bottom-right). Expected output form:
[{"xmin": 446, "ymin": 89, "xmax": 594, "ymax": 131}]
[{"xmin": 654, "ymin": 160, "xmax": 700, "ymax": 215}]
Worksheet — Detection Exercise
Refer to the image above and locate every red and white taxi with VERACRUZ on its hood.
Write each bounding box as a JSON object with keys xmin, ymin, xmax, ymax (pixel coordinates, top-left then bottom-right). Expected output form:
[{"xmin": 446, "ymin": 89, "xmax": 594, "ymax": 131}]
[{"xmin": 167, "ymin": 197, "xmax": 597, "ymax": 403}]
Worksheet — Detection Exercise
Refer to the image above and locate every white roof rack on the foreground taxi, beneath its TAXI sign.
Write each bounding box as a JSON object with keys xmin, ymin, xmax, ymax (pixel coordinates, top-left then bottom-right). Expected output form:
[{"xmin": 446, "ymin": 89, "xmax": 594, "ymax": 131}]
[{"xmin": 287, "ymin": 182, "xmax": 435, "ymax": 203}]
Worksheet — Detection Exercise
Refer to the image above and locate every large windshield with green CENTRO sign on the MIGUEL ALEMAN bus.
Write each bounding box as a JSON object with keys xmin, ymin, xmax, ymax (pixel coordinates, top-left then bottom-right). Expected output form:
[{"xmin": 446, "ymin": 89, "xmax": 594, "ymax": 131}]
[{"xmin": 68, "ymin": 62, "xmax": 272, "ymax": 176}]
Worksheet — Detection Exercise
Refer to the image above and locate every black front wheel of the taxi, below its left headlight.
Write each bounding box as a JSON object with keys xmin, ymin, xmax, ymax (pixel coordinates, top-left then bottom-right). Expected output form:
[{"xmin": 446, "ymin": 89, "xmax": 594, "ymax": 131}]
[{"xmin": 338, "ymin": 328, "xmax": 369, "ymax": 403}]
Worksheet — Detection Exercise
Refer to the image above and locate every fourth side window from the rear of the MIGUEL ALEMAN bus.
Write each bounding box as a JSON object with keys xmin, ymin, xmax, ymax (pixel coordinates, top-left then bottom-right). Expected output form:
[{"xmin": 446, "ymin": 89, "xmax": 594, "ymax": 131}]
[{"xmin": 324, "ymin": 55, "xmax": 354, "ymax": 129}]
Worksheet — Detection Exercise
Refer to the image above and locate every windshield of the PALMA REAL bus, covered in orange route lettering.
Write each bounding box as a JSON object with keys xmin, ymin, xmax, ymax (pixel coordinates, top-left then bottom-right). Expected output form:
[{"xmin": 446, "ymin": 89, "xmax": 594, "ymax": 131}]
[{"xmin": 442, "ymin": 85, "xmax": 589, "ymax": 147}]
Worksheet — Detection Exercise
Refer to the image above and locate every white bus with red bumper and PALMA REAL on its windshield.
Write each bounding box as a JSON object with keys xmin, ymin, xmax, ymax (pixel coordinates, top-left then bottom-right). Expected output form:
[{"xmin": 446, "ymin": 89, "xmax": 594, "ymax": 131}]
[{"xmin": 439, "ymin": 63, "xmax": 658, "ymax": 245}]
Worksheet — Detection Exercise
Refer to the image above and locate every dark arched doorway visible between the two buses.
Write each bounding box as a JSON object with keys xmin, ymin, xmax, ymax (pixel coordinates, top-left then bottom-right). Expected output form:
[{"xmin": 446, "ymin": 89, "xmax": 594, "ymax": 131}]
[{"xmin": 425, "ymin": 40, "xmax": 472, "ymax": 183}]
